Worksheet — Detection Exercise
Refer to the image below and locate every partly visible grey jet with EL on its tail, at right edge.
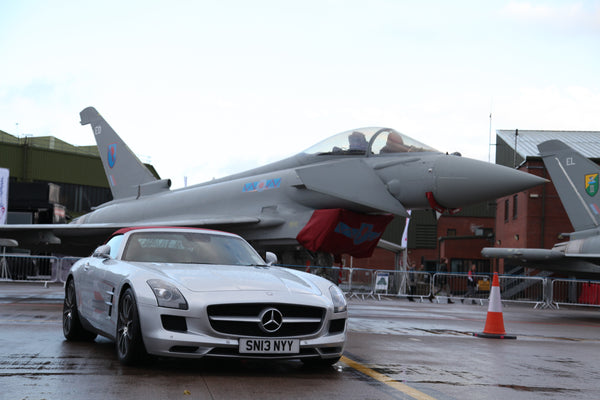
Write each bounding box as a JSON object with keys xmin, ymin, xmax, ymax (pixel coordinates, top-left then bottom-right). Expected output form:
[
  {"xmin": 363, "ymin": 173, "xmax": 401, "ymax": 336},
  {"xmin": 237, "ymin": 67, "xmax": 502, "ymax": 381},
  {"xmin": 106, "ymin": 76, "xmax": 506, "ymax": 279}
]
[{"xmin": 481, "ymin": 140, "xmax": 600, "ymax": 279}]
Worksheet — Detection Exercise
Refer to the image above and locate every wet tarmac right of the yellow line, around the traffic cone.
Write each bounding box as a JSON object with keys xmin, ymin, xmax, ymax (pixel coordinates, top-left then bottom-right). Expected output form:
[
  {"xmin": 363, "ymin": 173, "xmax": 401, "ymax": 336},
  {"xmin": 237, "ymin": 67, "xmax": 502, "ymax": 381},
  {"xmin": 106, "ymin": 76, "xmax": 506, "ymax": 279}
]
[{"xmin": 346, "ymin": 302, "xmax": 600, "ymax": 399}]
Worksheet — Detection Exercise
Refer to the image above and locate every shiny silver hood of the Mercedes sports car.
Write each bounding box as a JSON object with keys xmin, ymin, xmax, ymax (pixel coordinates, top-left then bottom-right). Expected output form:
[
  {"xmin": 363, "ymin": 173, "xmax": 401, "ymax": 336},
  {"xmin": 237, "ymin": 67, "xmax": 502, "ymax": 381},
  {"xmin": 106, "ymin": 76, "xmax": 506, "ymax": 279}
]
[{"xmin": 145, "ymin": 264, "xmax": 321, "ymax": 295}]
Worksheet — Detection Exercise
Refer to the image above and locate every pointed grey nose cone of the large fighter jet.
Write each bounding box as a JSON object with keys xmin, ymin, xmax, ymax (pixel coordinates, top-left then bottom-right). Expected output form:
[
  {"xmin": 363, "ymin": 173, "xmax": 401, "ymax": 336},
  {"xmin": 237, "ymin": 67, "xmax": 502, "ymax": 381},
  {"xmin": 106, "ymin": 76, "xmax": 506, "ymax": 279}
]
[{"xmin": 433, "ymin": 156, "xmax": 548, "ymax": 208}]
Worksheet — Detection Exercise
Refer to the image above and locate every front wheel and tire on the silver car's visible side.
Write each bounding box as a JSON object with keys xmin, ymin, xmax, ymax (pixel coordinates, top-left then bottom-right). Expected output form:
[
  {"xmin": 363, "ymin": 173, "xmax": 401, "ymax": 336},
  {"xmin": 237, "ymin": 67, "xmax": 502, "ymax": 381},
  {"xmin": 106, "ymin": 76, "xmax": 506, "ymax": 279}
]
[{"xmin": 117, "ymin": 288, "xmax": 146, "ymax": 365}]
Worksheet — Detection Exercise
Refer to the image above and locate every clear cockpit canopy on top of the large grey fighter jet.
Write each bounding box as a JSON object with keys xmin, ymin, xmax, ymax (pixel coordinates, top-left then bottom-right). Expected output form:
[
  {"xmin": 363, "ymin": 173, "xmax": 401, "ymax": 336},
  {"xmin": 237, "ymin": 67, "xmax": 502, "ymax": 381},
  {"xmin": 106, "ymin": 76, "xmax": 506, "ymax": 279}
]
[{"xmin": 304, "ymin": 127, "xmax": 438, "ymax": 156}]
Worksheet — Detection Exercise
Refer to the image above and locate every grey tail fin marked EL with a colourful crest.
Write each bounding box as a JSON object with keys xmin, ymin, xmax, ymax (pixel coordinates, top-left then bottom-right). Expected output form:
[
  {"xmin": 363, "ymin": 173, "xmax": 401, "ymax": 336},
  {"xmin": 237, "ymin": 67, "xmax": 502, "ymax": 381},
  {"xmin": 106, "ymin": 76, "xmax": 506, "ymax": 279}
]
[{"xmin": 538, "ymin": 140, "xmax": 600, "ymax": 231}]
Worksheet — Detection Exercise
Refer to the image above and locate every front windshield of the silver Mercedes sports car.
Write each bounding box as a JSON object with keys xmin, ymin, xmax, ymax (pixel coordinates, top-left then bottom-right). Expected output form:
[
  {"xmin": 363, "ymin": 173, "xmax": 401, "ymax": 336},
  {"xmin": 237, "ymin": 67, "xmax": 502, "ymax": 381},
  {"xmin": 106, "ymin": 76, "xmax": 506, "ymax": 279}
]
[{"xmin": 122, "ymin": 231, "xmax": 265, "ymax": 265}]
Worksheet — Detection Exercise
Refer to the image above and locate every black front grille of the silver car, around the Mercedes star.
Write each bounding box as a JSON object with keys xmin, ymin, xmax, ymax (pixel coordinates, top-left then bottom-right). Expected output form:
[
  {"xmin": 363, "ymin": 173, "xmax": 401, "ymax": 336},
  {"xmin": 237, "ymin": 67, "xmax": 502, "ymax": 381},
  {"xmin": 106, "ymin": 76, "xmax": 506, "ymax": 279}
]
[{"xmin": 207, "ymin": 303, "xmax": 325, "ymax": 337}]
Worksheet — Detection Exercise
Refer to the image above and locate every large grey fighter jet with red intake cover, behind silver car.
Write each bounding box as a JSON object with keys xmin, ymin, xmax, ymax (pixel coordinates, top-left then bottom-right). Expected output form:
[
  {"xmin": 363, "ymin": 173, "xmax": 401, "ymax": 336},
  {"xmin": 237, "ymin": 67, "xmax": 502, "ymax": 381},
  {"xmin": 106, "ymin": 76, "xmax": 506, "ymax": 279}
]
[{"xmin": 0, "ymin": 107, "xmax": 545, "ymax": 256}]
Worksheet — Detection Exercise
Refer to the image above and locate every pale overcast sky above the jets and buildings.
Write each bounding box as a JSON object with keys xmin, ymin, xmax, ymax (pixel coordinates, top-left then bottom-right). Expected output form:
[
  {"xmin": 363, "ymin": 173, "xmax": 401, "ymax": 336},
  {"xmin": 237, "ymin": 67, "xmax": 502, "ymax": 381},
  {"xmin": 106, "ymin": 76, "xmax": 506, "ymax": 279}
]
[{"xmin": 0, "ymin": 0, "xmax": 600, "ymax": 187}]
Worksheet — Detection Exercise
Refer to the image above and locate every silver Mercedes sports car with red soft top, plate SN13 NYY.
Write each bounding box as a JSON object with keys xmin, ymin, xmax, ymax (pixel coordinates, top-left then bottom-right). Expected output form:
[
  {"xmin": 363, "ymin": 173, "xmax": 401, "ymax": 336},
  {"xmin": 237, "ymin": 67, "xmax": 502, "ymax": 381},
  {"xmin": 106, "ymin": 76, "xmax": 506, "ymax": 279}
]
[{"xmin": 63, "ymin": 228, "xmax": 347, "ymax": 365}]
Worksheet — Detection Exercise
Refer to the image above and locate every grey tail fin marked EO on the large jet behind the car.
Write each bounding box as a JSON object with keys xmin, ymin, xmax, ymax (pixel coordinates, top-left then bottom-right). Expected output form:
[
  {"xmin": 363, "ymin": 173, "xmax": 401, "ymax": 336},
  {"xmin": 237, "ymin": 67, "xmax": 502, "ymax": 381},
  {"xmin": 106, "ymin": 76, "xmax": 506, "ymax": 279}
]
[{"xmin": 79, "ymin": 107, "xmax": 170, "ymax": 200}]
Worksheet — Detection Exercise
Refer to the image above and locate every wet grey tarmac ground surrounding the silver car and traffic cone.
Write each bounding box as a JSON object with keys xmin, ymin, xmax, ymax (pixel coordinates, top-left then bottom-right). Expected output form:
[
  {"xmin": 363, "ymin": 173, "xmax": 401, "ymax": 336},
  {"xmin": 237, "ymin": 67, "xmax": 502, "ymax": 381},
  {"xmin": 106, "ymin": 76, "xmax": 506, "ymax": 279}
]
[{"xmin": 0, "ymin": 283, "xmax": 600, "ymax": 400}]
